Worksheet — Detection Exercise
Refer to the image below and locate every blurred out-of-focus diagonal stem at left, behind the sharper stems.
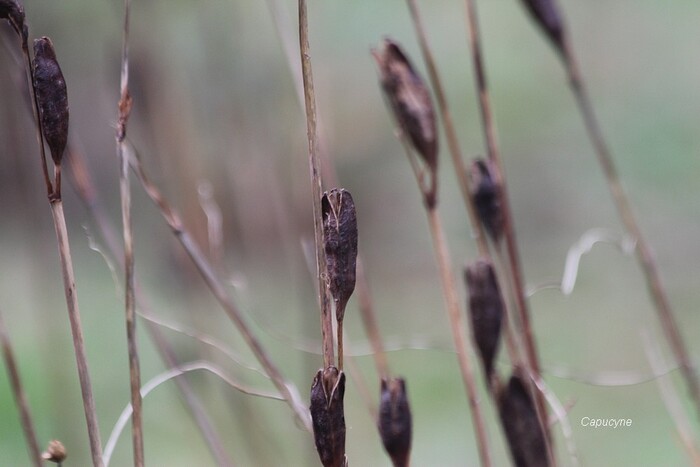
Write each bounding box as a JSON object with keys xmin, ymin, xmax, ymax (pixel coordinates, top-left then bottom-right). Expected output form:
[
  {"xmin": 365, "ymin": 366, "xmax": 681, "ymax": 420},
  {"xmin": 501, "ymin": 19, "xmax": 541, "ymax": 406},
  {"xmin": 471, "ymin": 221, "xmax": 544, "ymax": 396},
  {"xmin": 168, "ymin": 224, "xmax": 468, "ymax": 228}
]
[{"xmin": 68, "ymin": 144, "xmax": 233, "ymax": 467}]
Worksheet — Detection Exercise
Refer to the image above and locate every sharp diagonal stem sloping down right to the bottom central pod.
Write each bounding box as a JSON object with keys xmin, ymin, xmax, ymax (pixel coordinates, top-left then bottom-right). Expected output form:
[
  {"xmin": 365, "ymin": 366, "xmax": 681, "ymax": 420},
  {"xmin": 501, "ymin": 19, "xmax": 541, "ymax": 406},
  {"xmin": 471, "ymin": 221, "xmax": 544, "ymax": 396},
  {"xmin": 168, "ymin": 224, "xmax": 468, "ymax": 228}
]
[{"xmin": 127, "ymin": 151, "xmax": 311, "ymax": 432}]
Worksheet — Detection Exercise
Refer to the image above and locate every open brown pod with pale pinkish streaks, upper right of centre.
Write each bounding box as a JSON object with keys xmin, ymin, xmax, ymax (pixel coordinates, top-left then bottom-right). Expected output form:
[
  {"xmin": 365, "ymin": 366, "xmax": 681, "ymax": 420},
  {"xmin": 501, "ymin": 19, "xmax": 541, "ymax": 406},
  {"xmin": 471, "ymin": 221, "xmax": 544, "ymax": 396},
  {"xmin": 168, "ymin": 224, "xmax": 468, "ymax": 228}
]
[{"xmin": 372, "ymin": 39, "xmax": 438, "ymax": 172}]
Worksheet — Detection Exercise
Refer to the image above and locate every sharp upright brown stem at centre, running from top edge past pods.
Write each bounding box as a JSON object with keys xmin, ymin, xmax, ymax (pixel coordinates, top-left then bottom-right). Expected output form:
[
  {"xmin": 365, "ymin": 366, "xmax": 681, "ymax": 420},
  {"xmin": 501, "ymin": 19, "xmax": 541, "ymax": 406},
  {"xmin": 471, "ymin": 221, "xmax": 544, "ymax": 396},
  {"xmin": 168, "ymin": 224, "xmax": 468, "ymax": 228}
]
[{"xmin": 299, "ymin": 0, "xmax": 334, "ymax": 368}]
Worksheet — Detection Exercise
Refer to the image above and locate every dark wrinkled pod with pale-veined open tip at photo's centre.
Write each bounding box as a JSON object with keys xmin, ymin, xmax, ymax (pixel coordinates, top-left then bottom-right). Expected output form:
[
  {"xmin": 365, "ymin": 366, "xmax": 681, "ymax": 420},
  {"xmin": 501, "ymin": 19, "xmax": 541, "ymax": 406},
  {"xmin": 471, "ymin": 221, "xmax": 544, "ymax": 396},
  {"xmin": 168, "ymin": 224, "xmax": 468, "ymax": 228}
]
[{"xmin": 321, "ymin": 188, "xmax": 357, "ymax": 321}]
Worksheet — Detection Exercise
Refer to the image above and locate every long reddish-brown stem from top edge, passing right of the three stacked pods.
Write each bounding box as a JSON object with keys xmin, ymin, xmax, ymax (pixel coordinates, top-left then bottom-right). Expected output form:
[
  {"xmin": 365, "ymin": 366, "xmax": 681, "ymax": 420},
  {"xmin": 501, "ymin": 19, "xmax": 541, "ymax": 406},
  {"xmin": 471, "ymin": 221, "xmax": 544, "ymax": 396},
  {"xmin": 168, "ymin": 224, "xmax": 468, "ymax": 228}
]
[{"xmin": 466, "ymin": 0, "xmax": 551, "ymax": 438}]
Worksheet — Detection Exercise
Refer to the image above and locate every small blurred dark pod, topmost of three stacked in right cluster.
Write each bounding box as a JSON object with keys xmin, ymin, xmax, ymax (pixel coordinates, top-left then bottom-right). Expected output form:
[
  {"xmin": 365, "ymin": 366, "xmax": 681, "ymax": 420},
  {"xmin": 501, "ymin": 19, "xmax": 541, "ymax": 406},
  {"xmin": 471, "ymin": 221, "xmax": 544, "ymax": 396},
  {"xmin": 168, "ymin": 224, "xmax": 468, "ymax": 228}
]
[{"xmin": 470, "ymin": 159, "xmax": 503, "ymax": 242}]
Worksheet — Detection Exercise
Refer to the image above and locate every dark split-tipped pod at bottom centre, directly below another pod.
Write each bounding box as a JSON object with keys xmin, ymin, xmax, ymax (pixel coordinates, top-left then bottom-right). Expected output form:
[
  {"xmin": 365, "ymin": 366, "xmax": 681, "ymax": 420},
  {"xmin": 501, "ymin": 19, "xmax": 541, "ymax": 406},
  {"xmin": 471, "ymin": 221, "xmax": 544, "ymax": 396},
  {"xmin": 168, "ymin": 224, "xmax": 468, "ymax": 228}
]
[{"xmin": 310, "ymin": 366, "xmax": 346, "ymax": 467}]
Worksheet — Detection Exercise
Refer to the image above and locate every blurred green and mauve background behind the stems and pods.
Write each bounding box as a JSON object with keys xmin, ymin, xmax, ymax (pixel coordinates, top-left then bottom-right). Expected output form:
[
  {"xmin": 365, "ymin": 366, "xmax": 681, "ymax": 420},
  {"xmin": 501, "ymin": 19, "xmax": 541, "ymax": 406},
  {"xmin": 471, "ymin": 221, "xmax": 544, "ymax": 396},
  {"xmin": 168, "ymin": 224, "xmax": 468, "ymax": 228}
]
[{"xmin": 0, "ymin": 0, "xmax": 700, "ymax": 466}]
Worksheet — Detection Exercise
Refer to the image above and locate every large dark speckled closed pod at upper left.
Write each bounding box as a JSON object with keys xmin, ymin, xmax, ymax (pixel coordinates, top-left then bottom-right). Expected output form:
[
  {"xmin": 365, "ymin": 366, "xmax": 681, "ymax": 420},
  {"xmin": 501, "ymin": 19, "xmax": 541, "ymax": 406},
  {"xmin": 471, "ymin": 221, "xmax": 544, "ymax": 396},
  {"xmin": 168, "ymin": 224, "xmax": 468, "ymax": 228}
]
[{"xmin": 34, "ymin": 37, "xmax": 68, "ymax": 165}]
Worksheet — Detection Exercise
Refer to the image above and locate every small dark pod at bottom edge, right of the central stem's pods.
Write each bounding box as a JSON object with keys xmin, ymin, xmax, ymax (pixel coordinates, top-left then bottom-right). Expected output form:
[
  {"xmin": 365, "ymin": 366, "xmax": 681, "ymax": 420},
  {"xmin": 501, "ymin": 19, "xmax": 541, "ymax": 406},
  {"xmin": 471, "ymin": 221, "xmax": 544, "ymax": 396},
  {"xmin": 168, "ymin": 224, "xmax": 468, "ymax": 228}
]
[{"xmin": 378, "ymin": 378, "xmax": 412, "ymax": 467}]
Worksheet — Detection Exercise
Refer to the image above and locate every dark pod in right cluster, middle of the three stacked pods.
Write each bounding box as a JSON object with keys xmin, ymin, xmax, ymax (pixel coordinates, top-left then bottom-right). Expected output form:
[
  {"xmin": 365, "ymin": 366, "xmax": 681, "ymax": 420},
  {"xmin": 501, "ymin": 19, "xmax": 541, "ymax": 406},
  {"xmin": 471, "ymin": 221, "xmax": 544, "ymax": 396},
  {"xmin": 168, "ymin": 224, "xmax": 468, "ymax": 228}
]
[{"xmin": 464, "ymin": 259, "xmax": 504, "ymax": 379}]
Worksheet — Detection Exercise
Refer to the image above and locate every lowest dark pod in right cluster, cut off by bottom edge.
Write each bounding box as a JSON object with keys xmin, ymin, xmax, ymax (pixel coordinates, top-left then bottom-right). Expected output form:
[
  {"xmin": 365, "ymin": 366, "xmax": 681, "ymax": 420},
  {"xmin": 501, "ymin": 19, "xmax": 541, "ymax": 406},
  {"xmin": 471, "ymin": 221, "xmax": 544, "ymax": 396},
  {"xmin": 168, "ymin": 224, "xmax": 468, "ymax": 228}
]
[{"xmin": 498, "ymin": 374, "xmax": 549, "ymax": 467}]
